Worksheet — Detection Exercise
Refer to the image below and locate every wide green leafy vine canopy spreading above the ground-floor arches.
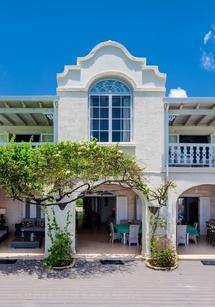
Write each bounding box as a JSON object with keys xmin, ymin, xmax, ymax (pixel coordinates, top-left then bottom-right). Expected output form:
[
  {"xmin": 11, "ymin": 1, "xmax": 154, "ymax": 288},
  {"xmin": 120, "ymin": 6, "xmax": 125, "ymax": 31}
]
[{"xmin": 0, "ymin": 140, "xmax": 148, "ymax": 206}]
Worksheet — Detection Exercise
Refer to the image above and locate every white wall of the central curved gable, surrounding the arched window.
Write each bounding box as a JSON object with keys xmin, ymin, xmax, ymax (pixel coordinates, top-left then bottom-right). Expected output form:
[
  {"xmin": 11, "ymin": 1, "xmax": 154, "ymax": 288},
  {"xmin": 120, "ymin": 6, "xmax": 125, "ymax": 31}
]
[{"xmin": 57, "ymin": 41, "xmax": 166, "ymax": 177}]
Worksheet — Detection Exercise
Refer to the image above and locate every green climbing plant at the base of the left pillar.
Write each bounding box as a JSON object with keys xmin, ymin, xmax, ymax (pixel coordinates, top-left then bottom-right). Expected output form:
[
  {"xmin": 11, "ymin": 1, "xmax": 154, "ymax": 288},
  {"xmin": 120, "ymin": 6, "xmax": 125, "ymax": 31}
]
[{"xmin": 44, "ymin": 209, "xmax": 75, "ymax": 270}]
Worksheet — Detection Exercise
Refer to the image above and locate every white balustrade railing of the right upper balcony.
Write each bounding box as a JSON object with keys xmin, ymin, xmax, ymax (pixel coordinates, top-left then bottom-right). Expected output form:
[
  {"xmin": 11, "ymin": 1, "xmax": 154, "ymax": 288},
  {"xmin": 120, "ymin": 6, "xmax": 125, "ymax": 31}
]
[{"xmin": 169, "ymin": 143, "xmax": 215, "ymax": 167}]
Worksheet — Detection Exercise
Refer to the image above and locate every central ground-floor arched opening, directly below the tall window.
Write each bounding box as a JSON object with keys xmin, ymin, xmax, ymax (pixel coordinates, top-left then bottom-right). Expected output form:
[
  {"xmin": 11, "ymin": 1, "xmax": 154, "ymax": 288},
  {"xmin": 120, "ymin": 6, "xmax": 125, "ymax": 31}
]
[{"xmin": 76, "ymin": 185, "xmax": 143, "ymax": 255}]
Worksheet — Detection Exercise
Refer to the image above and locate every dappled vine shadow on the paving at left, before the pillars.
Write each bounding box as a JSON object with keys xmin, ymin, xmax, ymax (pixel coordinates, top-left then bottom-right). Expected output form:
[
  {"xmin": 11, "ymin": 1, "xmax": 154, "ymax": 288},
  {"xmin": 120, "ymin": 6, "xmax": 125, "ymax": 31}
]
[{"xmin": 0, "ymin": 260, "xmax": 136, "ymax": 279}]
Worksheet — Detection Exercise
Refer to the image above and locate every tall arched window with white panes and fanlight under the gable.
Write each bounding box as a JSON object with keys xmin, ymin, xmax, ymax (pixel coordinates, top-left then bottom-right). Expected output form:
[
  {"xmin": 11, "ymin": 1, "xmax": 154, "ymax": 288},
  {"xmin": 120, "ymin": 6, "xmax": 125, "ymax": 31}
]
[{"xmin": 89, "ymin": 79, "xmax": 132, "ymax": 143}]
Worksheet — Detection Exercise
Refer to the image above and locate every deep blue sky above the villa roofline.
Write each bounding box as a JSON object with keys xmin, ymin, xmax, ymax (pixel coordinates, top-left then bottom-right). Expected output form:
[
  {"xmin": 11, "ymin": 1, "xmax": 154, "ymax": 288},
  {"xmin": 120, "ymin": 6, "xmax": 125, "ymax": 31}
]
[{"xmin": 0, "ymin": 0, "xmax": 215, "ymax": 96}]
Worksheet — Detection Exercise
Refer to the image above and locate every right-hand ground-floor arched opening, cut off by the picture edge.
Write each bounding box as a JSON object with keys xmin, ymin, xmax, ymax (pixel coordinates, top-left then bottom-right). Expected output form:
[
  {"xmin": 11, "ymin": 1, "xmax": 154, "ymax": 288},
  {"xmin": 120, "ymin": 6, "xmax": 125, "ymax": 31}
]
[{"xmin": 176, "ymin": 184, "xmax": 215, "ymax": 256}]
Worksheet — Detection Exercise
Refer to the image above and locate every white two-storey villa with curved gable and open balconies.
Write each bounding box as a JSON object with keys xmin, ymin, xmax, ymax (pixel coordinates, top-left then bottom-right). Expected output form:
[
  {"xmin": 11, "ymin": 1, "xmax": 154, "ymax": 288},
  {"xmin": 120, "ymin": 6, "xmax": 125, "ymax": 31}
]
[{"xmin": 0, "ymin": 41, "xmax": 215, "ymax": 255}]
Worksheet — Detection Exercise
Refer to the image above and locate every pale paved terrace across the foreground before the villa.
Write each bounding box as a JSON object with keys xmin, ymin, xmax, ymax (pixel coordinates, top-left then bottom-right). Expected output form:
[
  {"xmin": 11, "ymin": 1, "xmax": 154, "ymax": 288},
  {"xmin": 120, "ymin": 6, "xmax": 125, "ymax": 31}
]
[{"xmin": 0, "ymin": 260, "xmax": 215, "ymax": 307}]
